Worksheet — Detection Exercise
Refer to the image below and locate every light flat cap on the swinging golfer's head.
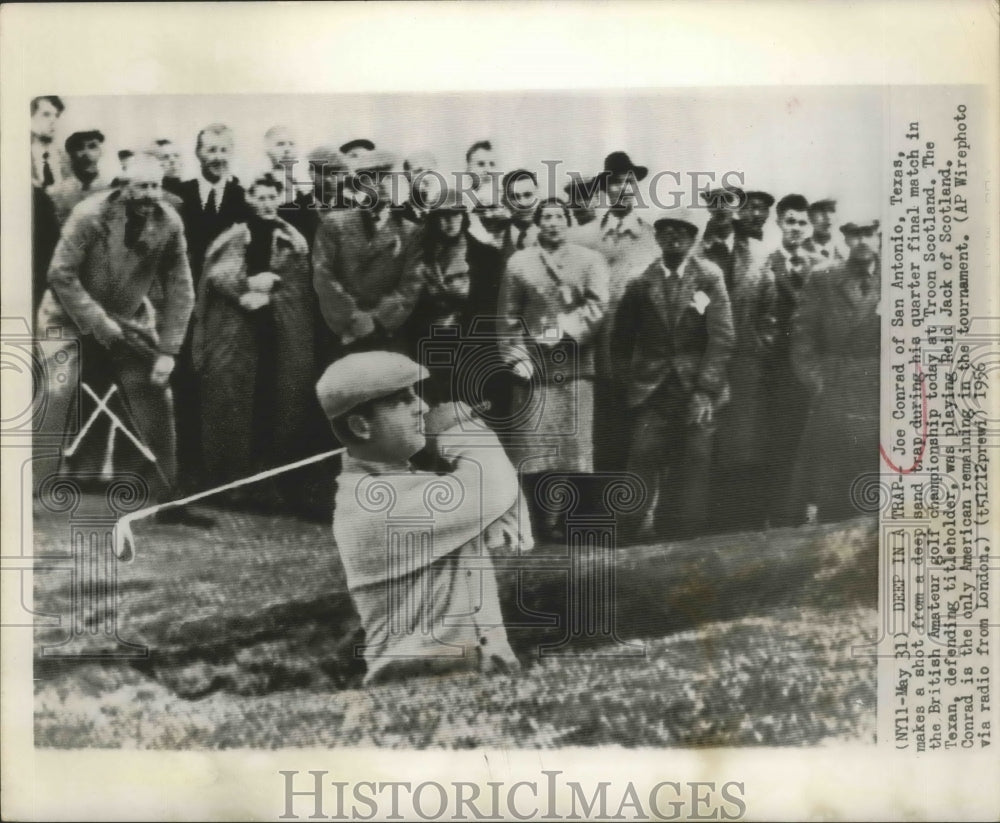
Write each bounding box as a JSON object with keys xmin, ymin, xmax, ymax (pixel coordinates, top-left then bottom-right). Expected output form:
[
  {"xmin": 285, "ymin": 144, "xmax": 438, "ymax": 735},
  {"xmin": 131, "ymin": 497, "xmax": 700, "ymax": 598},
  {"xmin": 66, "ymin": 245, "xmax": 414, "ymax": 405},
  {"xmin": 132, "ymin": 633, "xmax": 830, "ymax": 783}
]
[{"xmin": 316, "ymin": 351, "xmax": 429, "ymax": 420}]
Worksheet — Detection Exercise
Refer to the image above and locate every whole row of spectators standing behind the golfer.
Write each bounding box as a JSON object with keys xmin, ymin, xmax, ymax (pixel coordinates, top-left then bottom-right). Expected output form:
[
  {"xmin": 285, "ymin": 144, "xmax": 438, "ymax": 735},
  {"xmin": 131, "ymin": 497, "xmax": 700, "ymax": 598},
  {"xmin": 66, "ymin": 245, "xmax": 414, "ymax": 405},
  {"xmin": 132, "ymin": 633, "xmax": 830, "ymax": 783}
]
[{"xmin": 32, "ymin": 97, "xmax": 881, "ymax": 540}]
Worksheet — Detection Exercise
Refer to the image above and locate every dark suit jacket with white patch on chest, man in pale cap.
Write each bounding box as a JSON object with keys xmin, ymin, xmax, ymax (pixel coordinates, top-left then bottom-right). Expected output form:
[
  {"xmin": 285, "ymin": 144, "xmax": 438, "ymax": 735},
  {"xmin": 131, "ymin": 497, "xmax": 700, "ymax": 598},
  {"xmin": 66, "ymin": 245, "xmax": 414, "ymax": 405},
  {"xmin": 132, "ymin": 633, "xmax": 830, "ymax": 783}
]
[{"xmin": 611, "ymin": 255, "xmax": 735, "ymax": 408}]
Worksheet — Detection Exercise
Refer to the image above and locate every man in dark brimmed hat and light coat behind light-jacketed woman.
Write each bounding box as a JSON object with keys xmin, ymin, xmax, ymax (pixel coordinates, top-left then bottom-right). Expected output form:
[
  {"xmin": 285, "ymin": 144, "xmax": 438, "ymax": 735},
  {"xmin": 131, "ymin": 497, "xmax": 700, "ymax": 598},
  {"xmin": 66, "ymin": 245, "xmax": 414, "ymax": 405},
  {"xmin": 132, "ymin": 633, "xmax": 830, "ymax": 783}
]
[{"xmin": 571, "ymin": 151, "xmax": 659, "ymax": 471}]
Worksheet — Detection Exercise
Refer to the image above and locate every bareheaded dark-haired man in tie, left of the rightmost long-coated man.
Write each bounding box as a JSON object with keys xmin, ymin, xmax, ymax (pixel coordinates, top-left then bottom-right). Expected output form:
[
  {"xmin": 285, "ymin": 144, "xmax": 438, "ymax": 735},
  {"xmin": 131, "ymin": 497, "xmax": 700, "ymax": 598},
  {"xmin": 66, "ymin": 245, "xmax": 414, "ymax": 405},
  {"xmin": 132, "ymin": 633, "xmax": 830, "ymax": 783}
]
[{"xmin": 764, "ymin": 194, "xmax": 829, "ymax": 525}]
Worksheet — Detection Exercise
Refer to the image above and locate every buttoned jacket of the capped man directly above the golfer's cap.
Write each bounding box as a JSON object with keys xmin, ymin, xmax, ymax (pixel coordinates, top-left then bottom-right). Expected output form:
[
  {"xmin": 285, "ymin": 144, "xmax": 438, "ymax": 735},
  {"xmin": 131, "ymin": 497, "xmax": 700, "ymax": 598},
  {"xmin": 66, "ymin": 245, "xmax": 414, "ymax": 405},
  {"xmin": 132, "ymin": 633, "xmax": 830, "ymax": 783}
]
[{"xmin": 312, "ymin": 209, "xmax": 423, "ymax": 344}]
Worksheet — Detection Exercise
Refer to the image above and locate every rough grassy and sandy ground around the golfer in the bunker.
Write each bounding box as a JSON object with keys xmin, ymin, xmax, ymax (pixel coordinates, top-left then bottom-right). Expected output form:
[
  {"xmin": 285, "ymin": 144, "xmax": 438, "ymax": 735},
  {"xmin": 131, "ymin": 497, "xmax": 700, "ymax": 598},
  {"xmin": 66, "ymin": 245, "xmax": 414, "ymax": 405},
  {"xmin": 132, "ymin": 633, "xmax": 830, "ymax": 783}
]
[{"xmin": 35, "ymin": 498, "xmax": 877, "ymax": 749}]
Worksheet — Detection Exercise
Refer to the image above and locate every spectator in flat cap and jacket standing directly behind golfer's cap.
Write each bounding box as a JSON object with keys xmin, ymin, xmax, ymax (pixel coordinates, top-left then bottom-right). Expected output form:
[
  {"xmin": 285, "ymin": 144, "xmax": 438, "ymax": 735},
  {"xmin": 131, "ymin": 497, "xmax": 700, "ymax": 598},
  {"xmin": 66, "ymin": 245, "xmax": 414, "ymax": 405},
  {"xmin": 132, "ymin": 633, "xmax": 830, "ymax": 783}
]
[{"xmin": 312, "ymin": 151, "xmax": 423, "ymax": 353}]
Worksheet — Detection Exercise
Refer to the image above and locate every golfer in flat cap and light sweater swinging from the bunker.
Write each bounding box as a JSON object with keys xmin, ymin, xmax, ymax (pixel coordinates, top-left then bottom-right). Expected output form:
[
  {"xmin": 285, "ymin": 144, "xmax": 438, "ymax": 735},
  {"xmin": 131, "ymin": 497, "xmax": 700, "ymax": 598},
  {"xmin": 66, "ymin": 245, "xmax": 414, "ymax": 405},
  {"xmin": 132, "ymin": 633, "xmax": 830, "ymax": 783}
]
[{"xmin": 324, "ymin": 351, "xmax": 533, "ymax": 685}]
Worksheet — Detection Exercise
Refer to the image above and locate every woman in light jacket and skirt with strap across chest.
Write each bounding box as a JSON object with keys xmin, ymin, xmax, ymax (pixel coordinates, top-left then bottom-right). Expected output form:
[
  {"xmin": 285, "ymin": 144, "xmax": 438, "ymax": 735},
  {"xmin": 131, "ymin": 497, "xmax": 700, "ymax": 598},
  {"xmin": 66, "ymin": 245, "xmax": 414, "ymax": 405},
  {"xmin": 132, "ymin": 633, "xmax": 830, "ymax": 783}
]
[{"xmin": 499, "ymin": 198, "xmax": 609, "ymax": 536}]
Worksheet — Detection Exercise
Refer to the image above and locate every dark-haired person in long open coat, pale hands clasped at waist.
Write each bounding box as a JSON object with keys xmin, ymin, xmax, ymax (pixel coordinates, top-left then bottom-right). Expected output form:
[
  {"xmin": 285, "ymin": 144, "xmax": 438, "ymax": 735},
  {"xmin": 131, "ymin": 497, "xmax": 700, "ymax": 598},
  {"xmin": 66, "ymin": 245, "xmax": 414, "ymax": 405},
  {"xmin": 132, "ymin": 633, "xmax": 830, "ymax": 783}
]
[{"xmin": 193, "ymin": 177, "xmax": 316, "ymax": 496}]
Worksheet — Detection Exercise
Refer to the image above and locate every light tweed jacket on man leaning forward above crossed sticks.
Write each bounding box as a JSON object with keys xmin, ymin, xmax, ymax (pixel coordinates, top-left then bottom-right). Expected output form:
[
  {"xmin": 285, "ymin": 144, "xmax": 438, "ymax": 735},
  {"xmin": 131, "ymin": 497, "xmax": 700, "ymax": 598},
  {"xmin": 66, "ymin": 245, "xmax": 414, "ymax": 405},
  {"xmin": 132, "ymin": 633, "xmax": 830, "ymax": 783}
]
[{"xmin": 39, "ymin": 191, "xmax": 194, "ymax": 355}]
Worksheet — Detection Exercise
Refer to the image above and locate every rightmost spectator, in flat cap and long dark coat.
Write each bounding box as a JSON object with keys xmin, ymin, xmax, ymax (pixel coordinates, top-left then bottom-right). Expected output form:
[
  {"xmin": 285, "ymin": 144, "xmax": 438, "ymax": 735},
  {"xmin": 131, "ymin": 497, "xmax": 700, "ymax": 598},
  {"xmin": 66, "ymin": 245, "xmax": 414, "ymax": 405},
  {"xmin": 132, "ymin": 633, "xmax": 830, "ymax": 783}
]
[{"xmin": 790, "ymin": 220, "xmax": 882, "ymax": 521}]
